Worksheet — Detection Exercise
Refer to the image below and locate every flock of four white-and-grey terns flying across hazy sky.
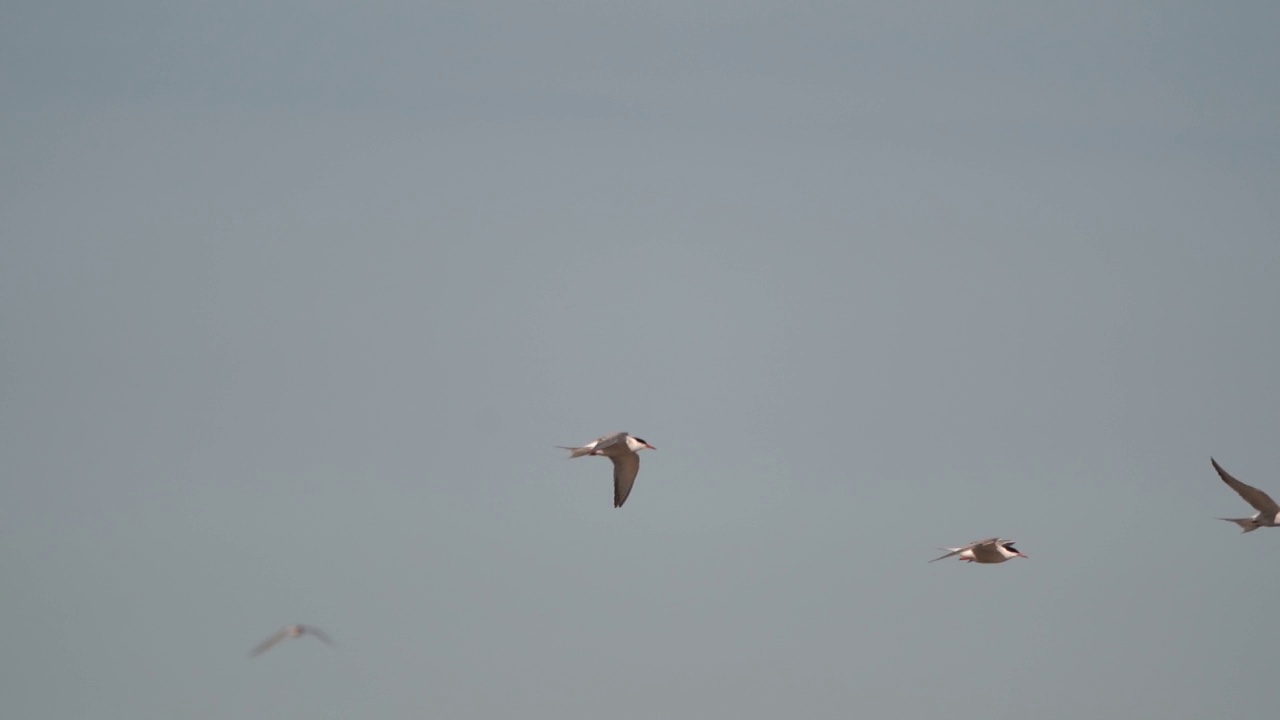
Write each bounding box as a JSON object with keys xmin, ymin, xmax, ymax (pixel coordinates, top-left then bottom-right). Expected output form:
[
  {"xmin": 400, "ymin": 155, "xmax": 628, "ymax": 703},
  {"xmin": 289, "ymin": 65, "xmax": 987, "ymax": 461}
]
[{"xmin": 250, "ymin": 433, "xmax": 1280, "ymax": 657}]
